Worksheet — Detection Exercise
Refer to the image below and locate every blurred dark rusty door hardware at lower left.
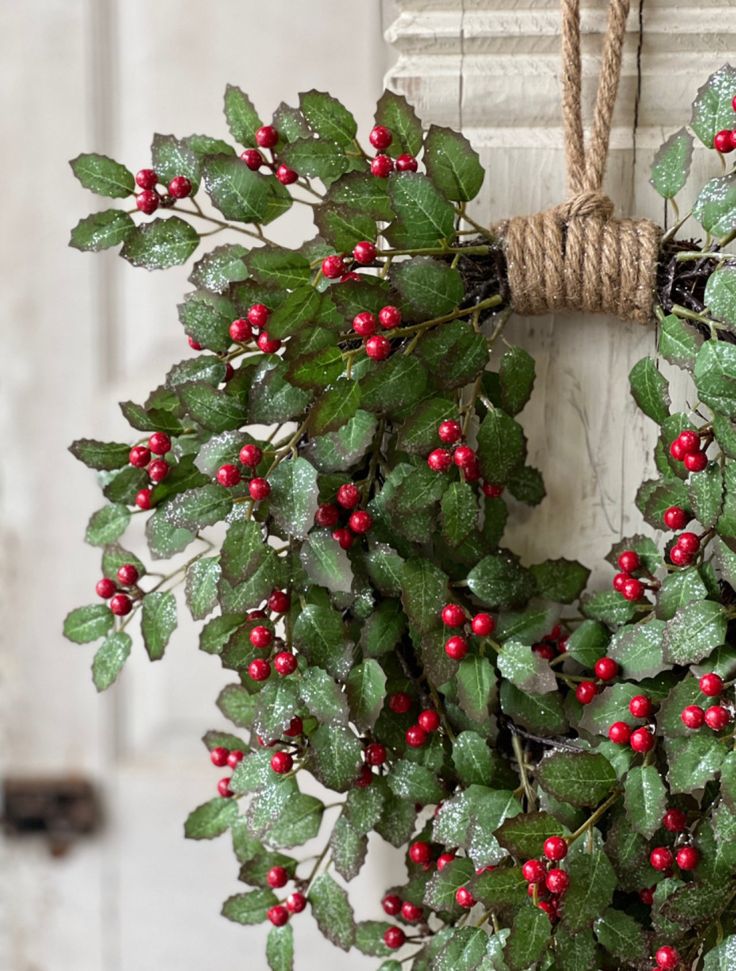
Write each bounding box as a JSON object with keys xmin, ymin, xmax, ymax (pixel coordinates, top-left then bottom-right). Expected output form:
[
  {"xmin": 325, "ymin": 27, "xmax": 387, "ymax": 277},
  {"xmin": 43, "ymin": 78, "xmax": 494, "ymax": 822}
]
[{"xmin": 2, "ymin": 776, "xmax": 101, "ymax": 856}]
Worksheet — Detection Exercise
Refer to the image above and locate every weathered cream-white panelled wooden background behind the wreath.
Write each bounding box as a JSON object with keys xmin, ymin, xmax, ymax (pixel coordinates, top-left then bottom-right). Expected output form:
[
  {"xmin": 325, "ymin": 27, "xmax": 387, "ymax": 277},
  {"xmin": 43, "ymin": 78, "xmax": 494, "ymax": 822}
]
[{"xmin": 0, "ymin": 0, "xmax": 736, "ymax": 971}]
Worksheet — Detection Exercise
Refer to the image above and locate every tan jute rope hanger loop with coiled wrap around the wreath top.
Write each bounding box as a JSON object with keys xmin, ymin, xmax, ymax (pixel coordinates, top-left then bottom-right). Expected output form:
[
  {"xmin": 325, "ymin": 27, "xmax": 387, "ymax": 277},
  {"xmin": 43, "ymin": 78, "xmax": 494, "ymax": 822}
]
[{"xmin": 498, "ymin": 0, "xmax": 662, "ymax": 323}]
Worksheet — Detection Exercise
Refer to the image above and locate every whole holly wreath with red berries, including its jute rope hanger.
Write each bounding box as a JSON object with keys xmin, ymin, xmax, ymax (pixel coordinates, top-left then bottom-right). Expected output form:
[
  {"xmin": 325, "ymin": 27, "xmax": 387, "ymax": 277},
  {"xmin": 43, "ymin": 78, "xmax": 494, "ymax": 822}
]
[{"xmin": 64, "ymin": 0, "xmax": 736, "ymax": 971}]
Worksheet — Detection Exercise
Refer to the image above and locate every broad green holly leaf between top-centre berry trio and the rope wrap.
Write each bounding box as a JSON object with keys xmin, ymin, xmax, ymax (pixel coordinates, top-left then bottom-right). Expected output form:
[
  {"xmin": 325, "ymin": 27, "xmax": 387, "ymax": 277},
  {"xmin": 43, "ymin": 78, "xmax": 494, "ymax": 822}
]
[{"xmin": 384, "ymin": 172, "xmax": 455, "ymax": 249}]
